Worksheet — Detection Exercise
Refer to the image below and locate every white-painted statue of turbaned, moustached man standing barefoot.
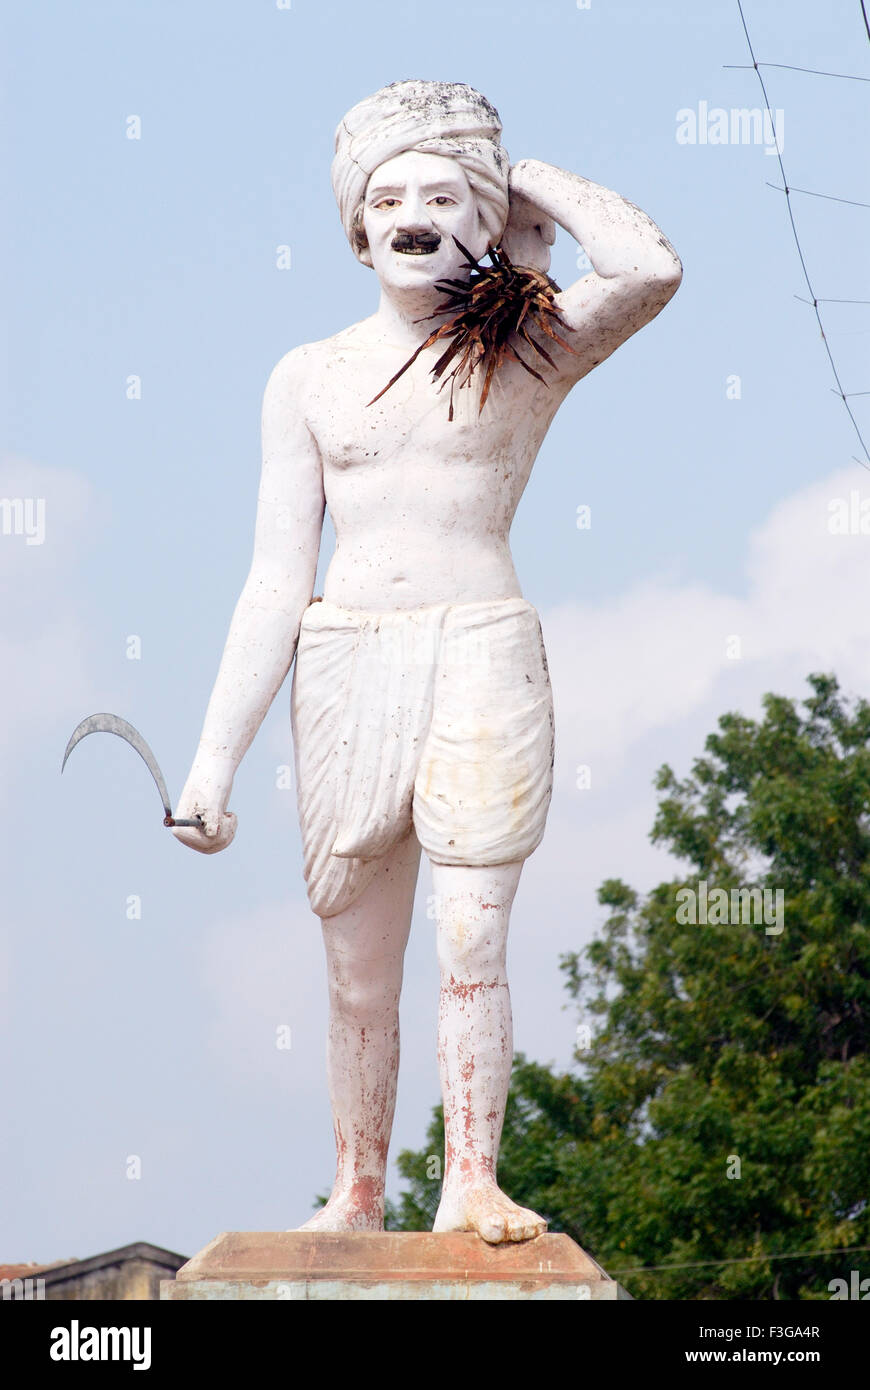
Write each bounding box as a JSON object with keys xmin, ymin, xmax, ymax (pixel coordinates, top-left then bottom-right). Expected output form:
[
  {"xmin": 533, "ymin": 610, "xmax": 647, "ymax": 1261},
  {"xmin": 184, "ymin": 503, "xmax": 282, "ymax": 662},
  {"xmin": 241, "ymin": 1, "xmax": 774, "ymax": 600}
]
[{"xmin": 175, "ymin": 81, "xmax": 681, "ymax": 1243}]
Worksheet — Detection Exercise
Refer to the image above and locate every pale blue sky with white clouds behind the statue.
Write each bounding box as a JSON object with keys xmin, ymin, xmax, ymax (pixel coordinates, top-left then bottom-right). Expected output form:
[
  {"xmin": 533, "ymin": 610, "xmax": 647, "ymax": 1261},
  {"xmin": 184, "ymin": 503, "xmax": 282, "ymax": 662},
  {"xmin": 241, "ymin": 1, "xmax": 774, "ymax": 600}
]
[{"xmin": 0, "ymin": 0, "xmax": 870, "ymax": 1259}]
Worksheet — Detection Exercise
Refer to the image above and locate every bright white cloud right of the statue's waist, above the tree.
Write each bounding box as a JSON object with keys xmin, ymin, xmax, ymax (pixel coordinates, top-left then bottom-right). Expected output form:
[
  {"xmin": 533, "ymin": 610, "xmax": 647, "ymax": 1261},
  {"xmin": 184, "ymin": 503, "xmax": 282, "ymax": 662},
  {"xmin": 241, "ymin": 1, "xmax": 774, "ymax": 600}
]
[{"xmin": 542, "ymin": 468, "xmax": 870, "ymax": 771}]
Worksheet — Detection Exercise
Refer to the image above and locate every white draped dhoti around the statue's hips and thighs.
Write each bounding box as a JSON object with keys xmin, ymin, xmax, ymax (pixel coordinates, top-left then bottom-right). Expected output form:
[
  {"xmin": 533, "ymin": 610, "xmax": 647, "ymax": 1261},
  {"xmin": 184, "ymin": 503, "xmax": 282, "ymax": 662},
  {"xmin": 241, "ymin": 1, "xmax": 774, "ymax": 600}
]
[{"xmin": 290, "ymin": 599, "xmax": 553, "ymax": 917}]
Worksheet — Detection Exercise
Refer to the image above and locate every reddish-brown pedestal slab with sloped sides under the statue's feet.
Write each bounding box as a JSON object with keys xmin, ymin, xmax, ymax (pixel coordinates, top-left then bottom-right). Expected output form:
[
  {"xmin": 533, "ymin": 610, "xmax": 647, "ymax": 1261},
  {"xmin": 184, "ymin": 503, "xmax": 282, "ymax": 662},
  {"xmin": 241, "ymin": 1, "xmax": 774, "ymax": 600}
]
[{"xmin": 160, "ymin": 1230, "xmax": 631, "ymax": 1301}]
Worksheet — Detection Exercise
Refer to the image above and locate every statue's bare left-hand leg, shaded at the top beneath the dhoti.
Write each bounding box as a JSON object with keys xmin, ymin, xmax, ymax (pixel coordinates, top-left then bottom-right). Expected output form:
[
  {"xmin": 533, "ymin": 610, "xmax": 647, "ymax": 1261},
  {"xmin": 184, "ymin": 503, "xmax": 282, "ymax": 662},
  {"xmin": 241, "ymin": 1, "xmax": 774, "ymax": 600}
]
[{"xmin": 294, "ymin": 831, "xmax": 420, "ymax": 1232}]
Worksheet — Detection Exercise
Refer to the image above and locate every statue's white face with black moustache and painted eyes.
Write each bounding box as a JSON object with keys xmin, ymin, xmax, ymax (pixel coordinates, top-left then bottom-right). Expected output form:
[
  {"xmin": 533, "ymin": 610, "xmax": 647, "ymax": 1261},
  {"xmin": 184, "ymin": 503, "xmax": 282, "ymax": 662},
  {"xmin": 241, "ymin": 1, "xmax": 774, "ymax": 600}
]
[{"xmin": 363, "ymin": 150, "xmax": 486, "ymax": 289}]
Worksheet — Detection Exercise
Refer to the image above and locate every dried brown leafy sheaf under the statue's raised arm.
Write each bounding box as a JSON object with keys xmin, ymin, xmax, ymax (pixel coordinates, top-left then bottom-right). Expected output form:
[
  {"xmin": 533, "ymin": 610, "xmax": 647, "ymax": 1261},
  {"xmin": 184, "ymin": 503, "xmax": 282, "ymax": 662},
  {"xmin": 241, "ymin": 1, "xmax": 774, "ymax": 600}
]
[{"xmin": 368, "ymin": 236, "xmax": 574, "ymax": 420}]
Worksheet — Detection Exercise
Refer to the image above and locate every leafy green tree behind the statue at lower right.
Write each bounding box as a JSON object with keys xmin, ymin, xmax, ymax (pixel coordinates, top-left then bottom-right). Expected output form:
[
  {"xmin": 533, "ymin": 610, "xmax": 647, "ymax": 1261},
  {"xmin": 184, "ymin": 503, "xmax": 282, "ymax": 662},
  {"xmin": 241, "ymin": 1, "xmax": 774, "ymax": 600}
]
[{"xmin": 391, "ymin": 676, "xmax": 870, "ymax": 1300}]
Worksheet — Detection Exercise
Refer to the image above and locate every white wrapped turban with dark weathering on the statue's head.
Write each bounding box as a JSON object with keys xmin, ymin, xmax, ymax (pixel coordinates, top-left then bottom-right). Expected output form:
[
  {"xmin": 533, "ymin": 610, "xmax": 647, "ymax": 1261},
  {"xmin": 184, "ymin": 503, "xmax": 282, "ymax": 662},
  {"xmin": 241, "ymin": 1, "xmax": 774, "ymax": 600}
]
[{"xmin": 332, "ymin": 79, "xmax": 510, "ymax": 264}]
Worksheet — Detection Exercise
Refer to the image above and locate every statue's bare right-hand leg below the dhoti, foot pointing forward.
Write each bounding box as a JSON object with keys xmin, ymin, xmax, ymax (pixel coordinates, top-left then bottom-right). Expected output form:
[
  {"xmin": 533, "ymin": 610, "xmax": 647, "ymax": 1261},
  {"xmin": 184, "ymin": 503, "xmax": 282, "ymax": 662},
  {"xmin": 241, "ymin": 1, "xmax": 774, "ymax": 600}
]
[{"xmin": 432, "ymin": 862, "xmax": 546, "ymax": 1244}]
